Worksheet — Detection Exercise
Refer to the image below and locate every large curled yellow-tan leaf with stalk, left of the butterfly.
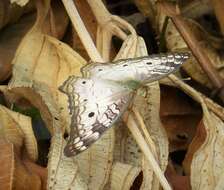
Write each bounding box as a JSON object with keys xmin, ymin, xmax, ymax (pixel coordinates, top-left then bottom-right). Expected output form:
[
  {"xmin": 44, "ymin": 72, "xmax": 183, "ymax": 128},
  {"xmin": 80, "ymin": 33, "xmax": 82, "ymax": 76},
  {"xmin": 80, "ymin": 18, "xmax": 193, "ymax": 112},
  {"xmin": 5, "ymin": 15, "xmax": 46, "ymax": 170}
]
[{"xmin": 9, "ymin": 2, "xmax": 85, "ymax": 131}]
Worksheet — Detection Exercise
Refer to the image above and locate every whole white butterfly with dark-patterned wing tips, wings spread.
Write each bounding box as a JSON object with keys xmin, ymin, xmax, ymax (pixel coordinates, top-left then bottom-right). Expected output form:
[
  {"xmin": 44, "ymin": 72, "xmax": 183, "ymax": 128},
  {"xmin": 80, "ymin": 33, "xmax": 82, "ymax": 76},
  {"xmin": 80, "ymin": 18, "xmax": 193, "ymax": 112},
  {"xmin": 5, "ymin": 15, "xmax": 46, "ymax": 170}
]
[{"xmin": 59, "ymin": 53, "xmax": 189, "ymax": 157}]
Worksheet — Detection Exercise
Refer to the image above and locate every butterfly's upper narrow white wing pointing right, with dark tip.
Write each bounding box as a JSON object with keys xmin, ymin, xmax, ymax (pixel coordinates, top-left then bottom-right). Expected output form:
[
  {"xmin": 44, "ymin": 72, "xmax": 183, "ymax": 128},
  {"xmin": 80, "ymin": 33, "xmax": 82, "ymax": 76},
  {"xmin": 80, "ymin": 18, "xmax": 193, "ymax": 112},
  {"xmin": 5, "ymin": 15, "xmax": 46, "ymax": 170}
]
[{"xmin": 82, "ymin": 53, "xmax": 189, "ymax": 84}]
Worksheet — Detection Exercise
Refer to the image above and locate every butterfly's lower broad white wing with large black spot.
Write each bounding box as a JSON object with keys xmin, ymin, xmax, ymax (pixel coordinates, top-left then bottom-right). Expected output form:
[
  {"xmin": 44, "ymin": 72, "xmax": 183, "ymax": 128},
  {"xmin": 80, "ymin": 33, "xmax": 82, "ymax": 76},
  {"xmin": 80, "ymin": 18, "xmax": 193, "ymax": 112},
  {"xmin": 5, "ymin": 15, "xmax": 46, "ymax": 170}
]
[{"xmin": 60, "ymin": 76, "xmax": 132, "ymax": 156}]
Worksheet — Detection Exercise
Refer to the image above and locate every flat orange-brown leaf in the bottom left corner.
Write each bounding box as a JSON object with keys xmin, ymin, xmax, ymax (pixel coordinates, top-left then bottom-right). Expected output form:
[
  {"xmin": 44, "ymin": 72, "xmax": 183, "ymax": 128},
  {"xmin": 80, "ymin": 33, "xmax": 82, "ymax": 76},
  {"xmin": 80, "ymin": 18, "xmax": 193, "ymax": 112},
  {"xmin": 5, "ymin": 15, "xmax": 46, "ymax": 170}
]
[{"xmin": 0, "ymin": 138, "xmax": 45, "ymax": 190}]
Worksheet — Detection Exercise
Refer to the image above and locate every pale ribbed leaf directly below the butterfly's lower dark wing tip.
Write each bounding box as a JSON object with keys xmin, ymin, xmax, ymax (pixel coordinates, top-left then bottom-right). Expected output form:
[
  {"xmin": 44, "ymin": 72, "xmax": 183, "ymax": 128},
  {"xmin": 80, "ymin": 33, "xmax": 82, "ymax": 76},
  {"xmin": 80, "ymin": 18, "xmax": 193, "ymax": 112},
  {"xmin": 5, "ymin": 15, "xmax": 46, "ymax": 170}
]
[{"xmin": 47, "ymin": 131, "xmax": 88, "ymax": 190}]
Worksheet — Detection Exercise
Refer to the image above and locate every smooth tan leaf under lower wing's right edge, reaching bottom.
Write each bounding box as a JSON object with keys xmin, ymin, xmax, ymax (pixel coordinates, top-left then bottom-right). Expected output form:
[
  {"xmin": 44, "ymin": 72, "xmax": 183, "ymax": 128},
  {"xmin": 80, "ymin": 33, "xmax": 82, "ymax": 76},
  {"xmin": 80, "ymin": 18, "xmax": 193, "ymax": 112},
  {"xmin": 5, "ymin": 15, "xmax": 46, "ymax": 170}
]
[{"xmin": 75, "ymin": 129, "xmax": 115, "ymax": 190}]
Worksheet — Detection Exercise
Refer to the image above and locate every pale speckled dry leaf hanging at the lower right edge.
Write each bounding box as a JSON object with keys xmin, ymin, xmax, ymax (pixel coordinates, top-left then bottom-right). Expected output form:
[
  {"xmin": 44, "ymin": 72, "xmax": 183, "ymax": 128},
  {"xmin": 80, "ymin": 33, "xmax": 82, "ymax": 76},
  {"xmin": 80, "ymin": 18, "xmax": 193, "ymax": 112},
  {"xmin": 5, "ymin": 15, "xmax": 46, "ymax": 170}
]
[{"xmin": 185, "ymin": 109, "xmax": 224, "ymax": 189}]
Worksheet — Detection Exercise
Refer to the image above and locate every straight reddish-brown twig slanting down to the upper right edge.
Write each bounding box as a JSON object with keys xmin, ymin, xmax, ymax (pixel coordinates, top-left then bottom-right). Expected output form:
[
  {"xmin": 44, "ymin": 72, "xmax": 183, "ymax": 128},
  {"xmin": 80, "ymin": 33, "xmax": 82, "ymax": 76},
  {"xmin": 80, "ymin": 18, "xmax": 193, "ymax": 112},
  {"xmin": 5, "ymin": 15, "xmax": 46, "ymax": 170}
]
[{"xmin": 158, "ymin": 2, "xmax": 224, "ymax": 102}]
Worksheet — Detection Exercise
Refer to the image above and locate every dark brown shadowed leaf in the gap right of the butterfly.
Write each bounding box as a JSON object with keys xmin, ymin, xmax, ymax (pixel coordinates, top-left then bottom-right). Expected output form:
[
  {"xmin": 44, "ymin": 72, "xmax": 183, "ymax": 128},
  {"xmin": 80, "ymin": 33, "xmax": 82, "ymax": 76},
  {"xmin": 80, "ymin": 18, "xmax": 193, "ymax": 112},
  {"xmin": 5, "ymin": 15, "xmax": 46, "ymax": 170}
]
[{"xmin": 160, "ymin": 86, "xmax": 202, "ymax": 152}]
